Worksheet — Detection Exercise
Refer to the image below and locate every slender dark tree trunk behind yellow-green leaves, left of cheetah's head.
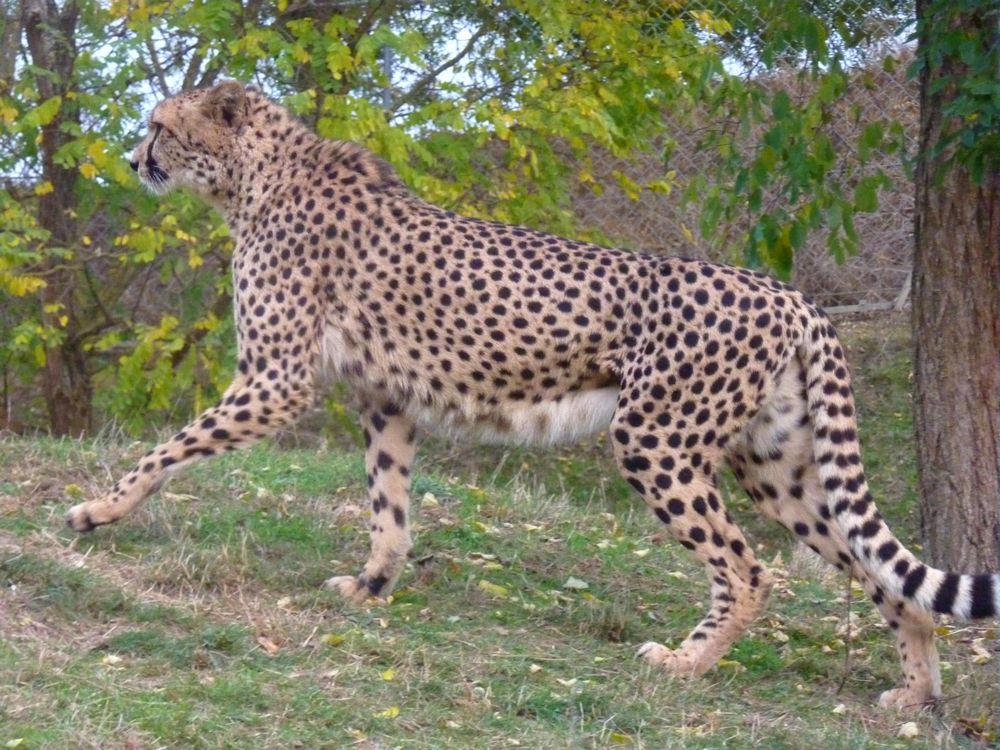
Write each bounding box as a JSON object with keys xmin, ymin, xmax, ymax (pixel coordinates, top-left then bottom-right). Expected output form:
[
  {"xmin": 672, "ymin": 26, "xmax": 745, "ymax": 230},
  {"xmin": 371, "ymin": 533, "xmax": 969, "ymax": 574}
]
[{"xmin": 22, "ymin": 0, "xmax": 93, "ymax": 436}]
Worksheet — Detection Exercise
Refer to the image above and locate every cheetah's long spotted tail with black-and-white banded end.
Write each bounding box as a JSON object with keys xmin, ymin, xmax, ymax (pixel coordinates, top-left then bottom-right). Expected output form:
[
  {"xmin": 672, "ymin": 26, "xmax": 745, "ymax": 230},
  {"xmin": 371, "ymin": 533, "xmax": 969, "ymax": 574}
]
[{"xmin": 799, "ymin": 317, "xmax": 1000, "ymax": 620}]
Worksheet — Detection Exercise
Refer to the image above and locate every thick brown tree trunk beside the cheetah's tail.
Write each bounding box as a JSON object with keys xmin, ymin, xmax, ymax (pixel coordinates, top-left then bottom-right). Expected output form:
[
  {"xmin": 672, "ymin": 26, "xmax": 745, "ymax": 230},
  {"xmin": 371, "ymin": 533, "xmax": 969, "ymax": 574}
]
[{"xmin": 913, "ymin": 0, "xmax": 1000, "ymax": 571}]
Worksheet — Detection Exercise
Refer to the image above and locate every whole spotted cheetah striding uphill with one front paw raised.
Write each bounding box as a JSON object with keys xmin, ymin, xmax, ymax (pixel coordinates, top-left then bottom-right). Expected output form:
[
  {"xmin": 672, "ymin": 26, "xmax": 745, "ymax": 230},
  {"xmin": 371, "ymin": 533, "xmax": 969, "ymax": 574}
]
[{"xmin": 67, "ymin": 82, "xmax": 1000, "ymax": 707}]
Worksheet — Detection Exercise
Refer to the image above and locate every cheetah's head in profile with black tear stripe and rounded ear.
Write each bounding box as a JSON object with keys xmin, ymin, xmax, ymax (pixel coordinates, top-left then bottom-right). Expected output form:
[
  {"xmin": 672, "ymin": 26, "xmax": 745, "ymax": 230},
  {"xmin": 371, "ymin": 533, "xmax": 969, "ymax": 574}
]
[{"xmin": 130, "ymin": 81, "xmax": 248, "ymax": 201}]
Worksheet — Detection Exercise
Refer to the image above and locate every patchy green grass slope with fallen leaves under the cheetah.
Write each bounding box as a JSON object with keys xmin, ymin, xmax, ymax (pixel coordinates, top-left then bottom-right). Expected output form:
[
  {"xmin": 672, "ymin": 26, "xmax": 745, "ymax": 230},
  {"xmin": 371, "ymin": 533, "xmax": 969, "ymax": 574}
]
[{"xmin": 0, "ymin": 318, "xmax": 1000, "ymax": 750}]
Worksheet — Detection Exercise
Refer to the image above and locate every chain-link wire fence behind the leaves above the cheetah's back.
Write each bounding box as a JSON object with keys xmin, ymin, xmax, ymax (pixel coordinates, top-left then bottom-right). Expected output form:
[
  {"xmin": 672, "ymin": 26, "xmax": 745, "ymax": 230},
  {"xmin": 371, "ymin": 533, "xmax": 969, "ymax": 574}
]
[{"xmin": 573, "ymin": 2, "xmax": 919, "ymax": 307}]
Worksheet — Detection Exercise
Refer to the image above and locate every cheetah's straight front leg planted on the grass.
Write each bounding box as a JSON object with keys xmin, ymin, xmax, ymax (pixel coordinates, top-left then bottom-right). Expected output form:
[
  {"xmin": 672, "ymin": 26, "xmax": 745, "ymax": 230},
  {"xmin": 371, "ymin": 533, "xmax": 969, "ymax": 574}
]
[{"xmin": 326, "ymin": 404, "xmax": 414, "ymax": 604}]
